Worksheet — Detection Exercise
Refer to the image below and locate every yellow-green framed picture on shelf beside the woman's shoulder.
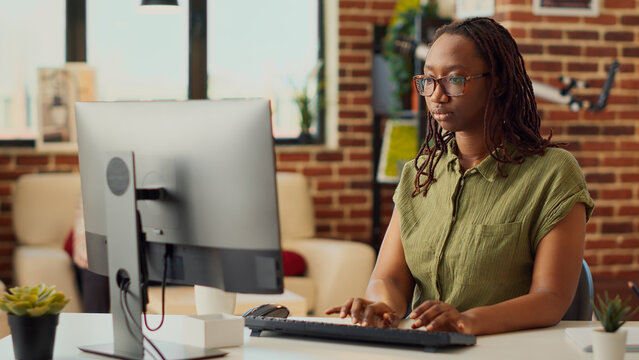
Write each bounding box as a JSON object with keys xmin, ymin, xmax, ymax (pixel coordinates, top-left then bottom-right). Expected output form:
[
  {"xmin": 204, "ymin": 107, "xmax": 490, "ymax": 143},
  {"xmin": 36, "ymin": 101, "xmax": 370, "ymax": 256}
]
[{"xmin": 377, "ymin": 119, "xmax": 418, "ymax": 184}]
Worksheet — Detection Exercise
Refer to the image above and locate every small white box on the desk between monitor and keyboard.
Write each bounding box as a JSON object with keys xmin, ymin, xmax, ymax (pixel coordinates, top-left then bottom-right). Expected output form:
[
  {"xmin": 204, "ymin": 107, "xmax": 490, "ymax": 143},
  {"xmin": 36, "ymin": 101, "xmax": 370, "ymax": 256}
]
[{"xmin": 182, "ymin": 314, "xmax": 244, "ymax": 349}]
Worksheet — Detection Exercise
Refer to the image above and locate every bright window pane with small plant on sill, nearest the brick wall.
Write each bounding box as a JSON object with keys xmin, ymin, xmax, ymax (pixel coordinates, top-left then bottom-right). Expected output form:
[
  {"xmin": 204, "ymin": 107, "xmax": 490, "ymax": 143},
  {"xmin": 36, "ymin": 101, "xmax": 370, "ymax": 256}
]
[{"xmin": 207, "ymin": 0, "xmax": 323, "ymax": 139}]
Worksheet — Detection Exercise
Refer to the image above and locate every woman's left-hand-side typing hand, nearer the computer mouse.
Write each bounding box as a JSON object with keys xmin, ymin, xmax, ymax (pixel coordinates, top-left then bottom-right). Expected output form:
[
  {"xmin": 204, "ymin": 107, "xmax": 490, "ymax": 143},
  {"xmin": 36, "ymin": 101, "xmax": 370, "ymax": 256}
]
[{"xmin": 325, "ymin": 298, "xmax": 400, "ymax": 327}]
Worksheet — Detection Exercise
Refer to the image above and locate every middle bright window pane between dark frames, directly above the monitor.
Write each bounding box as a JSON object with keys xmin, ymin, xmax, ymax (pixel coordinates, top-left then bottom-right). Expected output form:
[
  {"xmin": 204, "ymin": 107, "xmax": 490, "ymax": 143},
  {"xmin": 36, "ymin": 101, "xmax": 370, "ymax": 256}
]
[{"xmin": 87, "ymin": 0, "xmax": 189, "ymax": 100}]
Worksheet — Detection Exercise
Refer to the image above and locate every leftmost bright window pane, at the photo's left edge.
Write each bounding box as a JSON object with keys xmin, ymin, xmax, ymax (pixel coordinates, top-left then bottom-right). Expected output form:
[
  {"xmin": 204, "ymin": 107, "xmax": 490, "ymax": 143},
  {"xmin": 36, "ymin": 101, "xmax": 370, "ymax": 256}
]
[{"xmin": 0, "ymin": 0, "xmax": 65, "ymax": 140}]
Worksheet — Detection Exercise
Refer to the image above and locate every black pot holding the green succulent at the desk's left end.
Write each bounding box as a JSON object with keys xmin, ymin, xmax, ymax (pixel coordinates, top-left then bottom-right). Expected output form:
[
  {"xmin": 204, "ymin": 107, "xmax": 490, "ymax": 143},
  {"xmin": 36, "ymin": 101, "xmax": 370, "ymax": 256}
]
[{"xmin": 8, "ymin": 314, "xmax": 60, "ymax": 360}]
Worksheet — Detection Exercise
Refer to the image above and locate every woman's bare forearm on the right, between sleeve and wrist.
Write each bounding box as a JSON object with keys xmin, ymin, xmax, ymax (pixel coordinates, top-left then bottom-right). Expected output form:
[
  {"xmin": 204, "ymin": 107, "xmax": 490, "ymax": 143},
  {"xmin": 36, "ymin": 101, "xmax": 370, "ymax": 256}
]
[{"xmin": 463, "ymin": 291, "xmax": 567, "ymax": 335}]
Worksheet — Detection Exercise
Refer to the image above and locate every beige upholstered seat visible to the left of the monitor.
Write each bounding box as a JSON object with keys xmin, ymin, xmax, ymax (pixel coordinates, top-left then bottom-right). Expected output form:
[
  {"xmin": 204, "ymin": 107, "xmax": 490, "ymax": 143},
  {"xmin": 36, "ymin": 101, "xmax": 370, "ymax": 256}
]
[{"xmin": 13, "ymin": 173, "xmax": 82, "ymax": 312}]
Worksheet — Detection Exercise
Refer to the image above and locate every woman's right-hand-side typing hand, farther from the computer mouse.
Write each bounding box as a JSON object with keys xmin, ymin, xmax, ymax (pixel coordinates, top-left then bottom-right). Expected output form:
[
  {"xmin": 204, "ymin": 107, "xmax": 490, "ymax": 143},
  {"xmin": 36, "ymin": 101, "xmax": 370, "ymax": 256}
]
[{"xmin": 409, "ymin": 300, "xmax": 473, "ymax": 334}]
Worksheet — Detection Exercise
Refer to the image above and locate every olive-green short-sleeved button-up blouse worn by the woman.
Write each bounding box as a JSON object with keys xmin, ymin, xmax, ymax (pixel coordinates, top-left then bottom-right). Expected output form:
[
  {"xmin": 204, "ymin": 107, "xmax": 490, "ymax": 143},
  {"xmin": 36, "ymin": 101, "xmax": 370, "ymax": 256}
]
[{"xmin": 393, "ymin": 139, "xmax": 594, "ymax": 311}]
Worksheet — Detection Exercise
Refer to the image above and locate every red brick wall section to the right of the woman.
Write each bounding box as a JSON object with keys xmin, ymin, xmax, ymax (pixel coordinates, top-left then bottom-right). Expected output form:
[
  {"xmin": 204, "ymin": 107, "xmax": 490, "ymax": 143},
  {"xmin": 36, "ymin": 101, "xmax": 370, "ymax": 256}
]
[{"xmin": 495, "ymin": 0, "xmax": 639, "ymax": 279}]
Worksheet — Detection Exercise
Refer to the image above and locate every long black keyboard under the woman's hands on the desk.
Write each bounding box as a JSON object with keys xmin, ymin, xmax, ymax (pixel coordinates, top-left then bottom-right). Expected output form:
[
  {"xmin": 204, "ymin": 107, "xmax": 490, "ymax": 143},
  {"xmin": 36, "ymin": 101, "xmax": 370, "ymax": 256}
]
[{"xmin": 244, "ymin": 316, "xmax": 477, "ymax": 351}]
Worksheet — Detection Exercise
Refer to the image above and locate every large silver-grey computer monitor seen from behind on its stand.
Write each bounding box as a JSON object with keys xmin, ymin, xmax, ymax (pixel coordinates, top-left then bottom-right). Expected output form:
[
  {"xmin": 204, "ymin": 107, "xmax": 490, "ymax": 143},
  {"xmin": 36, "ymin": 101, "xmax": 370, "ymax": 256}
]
[{"xmin": 76, "ymin": 99, "xmax": 283, "ymax": 358}]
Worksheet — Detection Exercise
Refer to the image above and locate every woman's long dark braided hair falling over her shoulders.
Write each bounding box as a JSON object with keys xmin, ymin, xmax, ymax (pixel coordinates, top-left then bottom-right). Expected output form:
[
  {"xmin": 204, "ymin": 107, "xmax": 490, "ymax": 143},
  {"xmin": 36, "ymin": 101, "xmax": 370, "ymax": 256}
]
[{"xmin": 412, "ymin": 18, "xmax": 557, "ymax": 197}]
